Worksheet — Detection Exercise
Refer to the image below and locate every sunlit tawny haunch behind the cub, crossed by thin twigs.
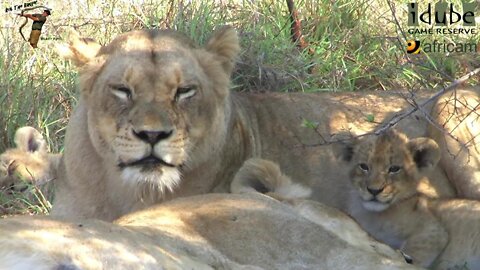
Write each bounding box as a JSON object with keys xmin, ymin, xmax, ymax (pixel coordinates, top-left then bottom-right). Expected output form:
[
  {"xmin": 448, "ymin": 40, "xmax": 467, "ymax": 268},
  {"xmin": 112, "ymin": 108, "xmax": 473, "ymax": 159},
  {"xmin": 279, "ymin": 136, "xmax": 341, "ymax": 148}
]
[{"xmin": 429, "ymin": 90, "xmax": 480, "ymax": 200}]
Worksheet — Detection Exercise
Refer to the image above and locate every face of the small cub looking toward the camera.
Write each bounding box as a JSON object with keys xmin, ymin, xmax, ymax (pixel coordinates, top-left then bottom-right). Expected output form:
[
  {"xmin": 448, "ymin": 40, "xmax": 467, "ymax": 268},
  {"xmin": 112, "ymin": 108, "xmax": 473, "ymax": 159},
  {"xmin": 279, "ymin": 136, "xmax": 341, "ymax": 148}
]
[{"xmin": 344, "ymin": 130, "xmax": 440, "ymax": 212}]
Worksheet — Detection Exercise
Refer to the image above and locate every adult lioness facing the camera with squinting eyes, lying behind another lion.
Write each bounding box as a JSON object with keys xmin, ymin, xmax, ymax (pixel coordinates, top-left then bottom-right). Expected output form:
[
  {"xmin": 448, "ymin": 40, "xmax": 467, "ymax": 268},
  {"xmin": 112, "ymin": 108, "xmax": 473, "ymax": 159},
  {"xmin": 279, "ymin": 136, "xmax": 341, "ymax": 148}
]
[{"xmin": 53, "ymin": 27, "xmax": 474, "ymax": 220}]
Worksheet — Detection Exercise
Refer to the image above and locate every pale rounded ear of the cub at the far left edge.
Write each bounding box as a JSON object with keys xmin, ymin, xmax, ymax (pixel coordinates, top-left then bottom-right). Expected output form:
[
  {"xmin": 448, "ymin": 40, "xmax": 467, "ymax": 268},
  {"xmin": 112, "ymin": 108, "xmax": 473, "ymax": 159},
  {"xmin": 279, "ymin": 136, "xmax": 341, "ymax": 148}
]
[{"xmin": 15, "ymin": 126, "xmax": 47, "ymax": 154}]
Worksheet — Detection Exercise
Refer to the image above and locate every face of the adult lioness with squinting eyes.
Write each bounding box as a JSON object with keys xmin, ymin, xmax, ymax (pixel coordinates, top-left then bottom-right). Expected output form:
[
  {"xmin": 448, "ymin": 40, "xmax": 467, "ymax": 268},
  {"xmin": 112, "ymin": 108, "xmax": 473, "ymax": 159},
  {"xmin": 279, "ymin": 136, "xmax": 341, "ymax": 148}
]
[{"xmin": 74, "ymin": 28, "xmax": 237, "ymax": 191}]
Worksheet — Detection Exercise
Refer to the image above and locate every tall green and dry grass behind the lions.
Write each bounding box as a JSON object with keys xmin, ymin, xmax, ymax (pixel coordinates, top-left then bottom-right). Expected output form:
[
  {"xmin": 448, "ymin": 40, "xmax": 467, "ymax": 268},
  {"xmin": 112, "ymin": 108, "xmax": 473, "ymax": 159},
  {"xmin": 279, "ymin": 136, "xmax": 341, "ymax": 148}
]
[{"xmin": 0, "ymin": 0, "xmax": 480, "ymax": 215}]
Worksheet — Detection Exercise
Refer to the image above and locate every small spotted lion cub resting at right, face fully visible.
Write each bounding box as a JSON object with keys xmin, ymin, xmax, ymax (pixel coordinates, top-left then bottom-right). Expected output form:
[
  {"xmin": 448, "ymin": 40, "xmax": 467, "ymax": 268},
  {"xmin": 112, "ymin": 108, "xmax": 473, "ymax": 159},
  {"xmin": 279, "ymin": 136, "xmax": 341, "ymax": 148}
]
[{"xmin": 343, "ymin": 130, "xmax": 480, "ymax": 269}]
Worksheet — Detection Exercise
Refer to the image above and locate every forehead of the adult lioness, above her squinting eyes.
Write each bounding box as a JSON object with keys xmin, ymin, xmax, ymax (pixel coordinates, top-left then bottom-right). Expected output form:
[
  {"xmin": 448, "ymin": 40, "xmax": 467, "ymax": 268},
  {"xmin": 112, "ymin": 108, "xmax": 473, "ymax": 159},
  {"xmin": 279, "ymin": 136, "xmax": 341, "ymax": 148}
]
[{"xmin": 99, "ymin": 30, "xmax": 201, "ymax": 91}]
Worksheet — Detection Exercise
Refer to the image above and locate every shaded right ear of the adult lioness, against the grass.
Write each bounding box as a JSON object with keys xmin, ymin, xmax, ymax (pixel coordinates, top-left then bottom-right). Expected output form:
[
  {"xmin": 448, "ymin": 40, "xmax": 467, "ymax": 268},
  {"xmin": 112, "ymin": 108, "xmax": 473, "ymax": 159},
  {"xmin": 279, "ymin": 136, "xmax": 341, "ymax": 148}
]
[{"xmin": 206, "ymin": 26, "xmax": 240, "ymax": 73}]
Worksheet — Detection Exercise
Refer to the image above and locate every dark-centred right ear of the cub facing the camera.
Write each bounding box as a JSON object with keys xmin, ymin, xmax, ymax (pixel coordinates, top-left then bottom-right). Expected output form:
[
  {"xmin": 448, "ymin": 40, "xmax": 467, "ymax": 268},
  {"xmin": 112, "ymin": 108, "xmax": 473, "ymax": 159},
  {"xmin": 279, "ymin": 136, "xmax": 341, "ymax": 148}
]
[{"xmin": 407, "ymin": 137, "xmax": 440, "ymax": 171}]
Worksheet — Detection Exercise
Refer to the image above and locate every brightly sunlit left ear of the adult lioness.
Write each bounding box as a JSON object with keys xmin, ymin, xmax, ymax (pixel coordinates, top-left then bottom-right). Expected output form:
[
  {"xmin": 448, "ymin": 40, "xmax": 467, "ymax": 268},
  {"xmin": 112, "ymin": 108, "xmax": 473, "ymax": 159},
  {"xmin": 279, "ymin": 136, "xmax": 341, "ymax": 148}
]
[{"xmin": 56, "ymin": 32, "xmax": 102, "ymax": 67}]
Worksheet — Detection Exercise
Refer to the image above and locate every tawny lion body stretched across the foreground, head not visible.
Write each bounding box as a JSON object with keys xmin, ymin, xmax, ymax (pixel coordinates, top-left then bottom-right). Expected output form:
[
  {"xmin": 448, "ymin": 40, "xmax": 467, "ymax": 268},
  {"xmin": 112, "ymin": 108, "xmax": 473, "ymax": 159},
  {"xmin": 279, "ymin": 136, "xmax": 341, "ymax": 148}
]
[{"xmin": 0, "ymin": 194, "xmax": 417, "ymax": 270}]
